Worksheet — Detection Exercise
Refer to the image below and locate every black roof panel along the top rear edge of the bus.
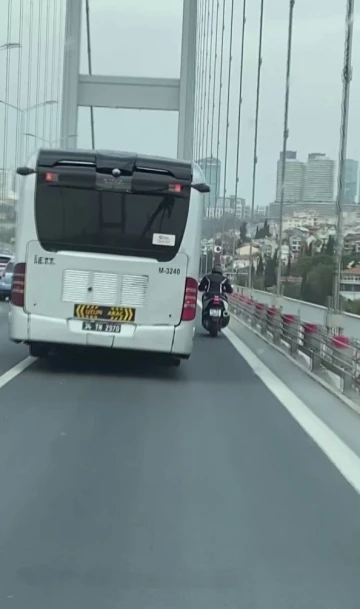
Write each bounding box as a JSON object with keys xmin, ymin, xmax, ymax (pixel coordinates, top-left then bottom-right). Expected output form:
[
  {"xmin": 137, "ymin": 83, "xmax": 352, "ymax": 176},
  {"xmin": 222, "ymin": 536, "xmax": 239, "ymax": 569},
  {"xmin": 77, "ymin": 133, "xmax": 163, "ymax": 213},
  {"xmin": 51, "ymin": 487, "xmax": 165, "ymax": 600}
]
[{"xmin": 37, "ymin": 148, "xmax": 193, "ymax": 183}]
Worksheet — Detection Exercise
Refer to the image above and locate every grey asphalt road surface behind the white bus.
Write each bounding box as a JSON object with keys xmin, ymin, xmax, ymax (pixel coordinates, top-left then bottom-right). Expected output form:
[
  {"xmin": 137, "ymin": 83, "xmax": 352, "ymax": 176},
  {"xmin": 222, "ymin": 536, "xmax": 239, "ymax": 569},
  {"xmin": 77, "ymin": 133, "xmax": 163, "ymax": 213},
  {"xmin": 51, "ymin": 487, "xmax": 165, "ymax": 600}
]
[{"xmin": 0, "ymin": 302, "xmax": 360, "ymax": 609}]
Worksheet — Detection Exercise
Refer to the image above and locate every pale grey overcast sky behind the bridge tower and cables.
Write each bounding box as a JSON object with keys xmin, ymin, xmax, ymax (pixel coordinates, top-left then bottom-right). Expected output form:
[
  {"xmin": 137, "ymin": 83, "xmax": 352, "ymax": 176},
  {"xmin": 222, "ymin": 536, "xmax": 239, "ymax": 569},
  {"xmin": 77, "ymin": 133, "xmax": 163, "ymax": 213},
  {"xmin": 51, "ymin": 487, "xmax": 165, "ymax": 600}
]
[{"xmin": 0, "ymin": 0, "xmax": 360, "ymax": 205}]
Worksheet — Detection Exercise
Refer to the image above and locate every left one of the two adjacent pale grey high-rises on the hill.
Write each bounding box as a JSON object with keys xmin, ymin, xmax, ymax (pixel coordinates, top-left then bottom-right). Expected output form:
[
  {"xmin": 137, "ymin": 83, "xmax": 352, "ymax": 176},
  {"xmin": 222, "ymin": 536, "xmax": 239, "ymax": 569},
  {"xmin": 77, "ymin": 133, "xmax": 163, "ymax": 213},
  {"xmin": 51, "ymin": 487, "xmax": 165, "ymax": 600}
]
[{"xmin": 276, "ymin": 150, "xmax": 305, "ymax": 203}]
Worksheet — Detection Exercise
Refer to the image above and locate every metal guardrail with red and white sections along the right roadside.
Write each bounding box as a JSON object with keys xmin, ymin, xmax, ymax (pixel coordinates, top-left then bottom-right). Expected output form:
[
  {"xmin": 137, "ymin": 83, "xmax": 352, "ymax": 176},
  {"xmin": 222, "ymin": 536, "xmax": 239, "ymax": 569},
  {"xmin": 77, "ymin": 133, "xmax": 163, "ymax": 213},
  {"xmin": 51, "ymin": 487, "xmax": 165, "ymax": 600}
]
[{"xmin": 229, "ymin": 292, "xmax": 360, "ymax": 406}]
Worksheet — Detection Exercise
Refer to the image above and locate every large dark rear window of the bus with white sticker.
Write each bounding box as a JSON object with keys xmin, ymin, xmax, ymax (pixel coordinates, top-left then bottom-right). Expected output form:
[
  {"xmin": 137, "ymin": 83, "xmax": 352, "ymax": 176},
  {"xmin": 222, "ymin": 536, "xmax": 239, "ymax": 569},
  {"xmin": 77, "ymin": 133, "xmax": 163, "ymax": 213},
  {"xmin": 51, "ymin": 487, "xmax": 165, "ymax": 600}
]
[{"xmin": 35, "ymin": 183, "xmax": 190, "ymax": 262}]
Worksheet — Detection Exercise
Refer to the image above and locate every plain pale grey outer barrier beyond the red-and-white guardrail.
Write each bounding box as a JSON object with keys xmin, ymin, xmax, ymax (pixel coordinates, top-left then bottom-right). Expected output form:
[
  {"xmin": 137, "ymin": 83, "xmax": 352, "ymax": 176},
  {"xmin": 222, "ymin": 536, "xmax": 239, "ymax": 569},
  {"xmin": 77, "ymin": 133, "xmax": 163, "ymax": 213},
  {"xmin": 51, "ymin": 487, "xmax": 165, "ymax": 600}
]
[{"xmin": 234, "ymin": 286, "xmax": 360, "ymax": 341}]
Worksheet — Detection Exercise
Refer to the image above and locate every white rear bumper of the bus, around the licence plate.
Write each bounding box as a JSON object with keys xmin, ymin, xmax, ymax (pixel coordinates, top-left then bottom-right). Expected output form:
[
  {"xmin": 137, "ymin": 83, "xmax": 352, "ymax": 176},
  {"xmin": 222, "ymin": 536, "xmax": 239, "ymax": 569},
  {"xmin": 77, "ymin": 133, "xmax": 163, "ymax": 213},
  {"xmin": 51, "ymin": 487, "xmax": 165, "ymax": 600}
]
[{"xmin": 9, "ymin": 306, "xmax": 194, "ymax": 358}]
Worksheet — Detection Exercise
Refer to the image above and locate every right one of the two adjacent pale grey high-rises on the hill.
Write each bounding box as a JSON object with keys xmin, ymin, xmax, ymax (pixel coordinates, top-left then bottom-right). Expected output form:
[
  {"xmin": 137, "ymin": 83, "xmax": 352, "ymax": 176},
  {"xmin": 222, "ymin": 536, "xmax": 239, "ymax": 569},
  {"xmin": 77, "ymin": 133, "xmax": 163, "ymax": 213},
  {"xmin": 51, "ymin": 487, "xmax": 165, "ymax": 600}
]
[{"xmin": 303, "ymin": 152, "xmax": 335, "ymax": 202}]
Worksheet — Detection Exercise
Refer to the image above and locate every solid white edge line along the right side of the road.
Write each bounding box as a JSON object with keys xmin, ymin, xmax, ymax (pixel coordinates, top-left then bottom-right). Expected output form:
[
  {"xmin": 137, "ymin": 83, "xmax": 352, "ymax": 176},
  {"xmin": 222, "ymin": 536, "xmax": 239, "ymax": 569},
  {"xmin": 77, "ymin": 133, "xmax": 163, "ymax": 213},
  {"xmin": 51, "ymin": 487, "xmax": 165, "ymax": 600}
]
[{"xmin": 198, "ymin": 302, "xmax": 360, "ymax": 494}]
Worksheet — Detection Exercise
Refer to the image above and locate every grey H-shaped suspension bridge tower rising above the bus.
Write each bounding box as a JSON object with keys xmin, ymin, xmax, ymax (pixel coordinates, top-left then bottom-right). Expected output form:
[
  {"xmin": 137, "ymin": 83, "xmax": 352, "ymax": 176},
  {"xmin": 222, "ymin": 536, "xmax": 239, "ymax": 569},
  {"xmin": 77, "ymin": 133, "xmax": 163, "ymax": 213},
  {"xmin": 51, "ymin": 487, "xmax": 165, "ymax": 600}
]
[{"xmin": 61, "ymin": 0, "xmax": 197, "ymax": 160}]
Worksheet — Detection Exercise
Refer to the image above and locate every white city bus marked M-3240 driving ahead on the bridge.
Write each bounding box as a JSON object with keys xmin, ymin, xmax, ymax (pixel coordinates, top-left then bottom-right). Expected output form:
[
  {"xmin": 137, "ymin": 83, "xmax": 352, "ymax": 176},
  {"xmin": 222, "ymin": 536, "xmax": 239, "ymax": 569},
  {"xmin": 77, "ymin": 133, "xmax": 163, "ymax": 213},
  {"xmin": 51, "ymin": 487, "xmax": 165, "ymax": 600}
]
[{"xmin": 9, "ymin": 149, "xmax": 209, "ymax": 365}]
